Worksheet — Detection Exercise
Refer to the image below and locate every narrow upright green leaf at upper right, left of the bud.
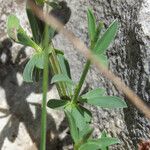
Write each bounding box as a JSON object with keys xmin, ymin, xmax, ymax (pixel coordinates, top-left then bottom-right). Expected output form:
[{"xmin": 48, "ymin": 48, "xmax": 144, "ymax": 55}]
[{"xmin": 87, "ymin": 9, "xmax": 96, "ymax": 43}]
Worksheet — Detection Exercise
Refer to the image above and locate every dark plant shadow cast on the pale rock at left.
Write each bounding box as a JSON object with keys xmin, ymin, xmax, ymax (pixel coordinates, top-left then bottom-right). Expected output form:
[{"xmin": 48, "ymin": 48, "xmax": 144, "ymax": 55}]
[{"xmin": 0, "ymin": 39, "xmax": 58, "ymax": 150}]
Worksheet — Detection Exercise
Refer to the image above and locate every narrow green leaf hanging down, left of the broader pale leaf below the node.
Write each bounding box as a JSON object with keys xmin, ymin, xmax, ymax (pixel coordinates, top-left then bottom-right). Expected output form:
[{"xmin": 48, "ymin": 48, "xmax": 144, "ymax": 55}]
[{"xmin": 65, "ymin": 110, "xmax": 79, "ymax": 143}]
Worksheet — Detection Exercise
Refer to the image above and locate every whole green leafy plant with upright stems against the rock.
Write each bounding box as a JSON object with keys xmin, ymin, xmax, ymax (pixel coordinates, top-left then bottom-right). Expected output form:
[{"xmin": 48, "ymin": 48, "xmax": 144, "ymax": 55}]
[{"xmin": 7, "ymin": 0, "xmax": 127, "ymax": 150}]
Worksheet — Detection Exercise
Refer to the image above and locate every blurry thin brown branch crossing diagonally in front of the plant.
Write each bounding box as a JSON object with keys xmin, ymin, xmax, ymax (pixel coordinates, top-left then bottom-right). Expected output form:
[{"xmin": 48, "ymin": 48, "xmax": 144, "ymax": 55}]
[{"xmin": 28, "ymin": 0, "xmax": 150, "ymax": 119}]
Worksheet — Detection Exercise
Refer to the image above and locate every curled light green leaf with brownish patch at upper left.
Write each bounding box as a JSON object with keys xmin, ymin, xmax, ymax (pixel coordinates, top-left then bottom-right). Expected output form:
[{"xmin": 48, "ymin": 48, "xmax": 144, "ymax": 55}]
[{"xmin": 7, "ymin": 15, "xmax": 42, "ymax": 51}]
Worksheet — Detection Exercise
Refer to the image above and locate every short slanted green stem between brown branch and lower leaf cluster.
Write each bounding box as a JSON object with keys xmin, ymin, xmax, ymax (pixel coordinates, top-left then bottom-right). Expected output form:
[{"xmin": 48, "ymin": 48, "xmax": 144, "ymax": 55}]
[{"xmin": 72, "ymin": 60, "xmax": 91, "ymax": 103}]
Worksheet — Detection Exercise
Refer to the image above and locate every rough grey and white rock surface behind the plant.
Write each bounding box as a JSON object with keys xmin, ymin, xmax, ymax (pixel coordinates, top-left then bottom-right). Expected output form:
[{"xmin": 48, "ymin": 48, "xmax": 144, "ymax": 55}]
[{"xmin": 0, "ymin": 0, "xmax": 150, "ymax": 150}]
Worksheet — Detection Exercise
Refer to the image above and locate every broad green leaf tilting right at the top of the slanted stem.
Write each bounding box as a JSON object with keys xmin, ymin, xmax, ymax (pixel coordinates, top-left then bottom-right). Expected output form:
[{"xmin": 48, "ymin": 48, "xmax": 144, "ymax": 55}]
[{"xmin": 94, "ymin": 20, "xmax": 118, "ymax": 54}]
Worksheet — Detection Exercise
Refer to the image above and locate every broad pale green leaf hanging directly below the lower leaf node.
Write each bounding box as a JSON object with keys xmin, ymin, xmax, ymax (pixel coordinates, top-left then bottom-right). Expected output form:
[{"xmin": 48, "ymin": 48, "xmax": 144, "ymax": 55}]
[{"xmin": 71, "ymin": 107, "xmax": 86, "ymax": 131}]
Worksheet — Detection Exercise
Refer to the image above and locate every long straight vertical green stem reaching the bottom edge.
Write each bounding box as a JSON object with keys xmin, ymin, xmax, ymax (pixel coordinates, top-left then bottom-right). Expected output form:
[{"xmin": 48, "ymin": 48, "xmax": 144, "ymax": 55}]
[{"xmin": 40, "ymin": 25, "xmax": 49, "ymax": 150}]
